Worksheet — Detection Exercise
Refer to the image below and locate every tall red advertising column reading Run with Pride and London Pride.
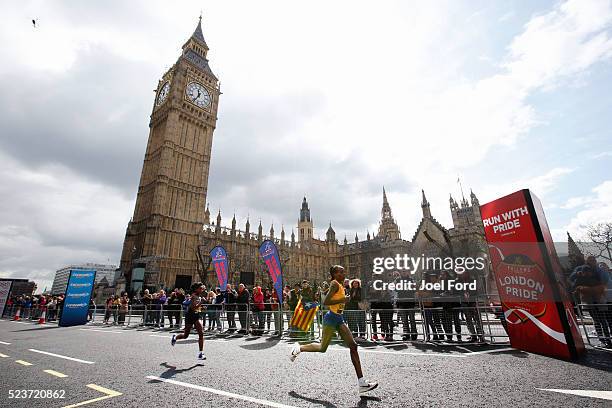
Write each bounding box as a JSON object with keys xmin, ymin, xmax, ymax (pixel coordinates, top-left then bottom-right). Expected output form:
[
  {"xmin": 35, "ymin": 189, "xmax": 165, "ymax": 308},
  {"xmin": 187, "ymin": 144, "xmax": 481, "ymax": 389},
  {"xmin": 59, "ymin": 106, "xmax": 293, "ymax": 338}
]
[{"xmin": 480, "ymin": 189, "xmax": 584, "ymax": 360}]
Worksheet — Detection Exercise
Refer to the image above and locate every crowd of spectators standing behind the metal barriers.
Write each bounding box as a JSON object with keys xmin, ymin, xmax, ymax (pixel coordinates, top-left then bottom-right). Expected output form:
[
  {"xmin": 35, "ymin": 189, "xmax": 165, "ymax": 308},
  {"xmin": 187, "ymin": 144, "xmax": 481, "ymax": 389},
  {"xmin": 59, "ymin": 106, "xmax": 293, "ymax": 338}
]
[{"xmin": 5, "ymin": 256, "xmax": 612, "ymax": 348}]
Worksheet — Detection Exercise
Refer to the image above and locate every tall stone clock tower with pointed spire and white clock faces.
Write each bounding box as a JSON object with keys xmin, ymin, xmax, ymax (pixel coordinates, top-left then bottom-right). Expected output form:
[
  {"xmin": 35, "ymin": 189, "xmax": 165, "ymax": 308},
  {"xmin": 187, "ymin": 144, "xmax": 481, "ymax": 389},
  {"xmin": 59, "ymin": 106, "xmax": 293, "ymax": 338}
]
[{"xmin": 121, "ymin": 17, "xmax": 221, "ymax": 290}]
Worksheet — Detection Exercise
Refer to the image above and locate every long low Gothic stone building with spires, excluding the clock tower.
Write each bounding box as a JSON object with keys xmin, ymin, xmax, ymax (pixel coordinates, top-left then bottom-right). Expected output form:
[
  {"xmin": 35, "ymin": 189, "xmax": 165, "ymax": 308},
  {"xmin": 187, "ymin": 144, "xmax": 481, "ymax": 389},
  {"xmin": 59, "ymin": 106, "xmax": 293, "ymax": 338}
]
[{"xmin": 200, "ymin": 188, "xmax": 488, "ymax": 294}]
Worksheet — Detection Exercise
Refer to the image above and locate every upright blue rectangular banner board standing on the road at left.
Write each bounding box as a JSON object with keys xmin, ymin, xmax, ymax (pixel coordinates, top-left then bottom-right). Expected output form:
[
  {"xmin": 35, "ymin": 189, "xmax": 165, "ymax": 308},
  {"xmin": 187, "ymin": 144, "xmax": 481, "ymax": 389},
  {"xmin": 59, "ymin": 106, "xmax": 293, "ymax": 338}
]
[{"xmin": 59, "ymin": 270, "xmax": 96, "ymax": 326}]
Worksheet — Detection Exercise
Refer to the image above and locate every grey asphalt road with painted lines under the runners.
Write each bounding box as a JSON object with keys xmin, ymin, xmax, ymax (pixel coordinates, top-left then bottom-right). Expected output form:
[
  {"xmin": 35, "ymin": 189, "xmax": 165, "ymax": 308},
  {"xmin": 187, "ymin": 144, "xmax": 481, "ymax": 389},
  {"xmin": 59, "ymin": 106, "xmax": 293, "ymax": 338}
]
[{"xmin": 0, "ymin": 320, "xmax": 612, "ymax": 408}]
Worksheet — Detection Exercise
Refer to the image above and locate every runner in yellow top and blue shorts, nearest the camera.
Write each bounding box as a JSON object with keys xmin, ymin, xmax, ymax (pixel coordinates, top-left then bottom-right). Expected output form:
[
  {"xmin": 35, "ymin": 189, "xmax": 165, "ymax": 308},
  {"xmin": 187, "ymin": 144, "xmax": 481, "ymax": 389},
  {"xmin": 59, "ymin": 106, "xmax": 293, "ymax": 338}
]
[{"xmin": 290, "ymin": 265, "xmax": 378, "ymax": 394}]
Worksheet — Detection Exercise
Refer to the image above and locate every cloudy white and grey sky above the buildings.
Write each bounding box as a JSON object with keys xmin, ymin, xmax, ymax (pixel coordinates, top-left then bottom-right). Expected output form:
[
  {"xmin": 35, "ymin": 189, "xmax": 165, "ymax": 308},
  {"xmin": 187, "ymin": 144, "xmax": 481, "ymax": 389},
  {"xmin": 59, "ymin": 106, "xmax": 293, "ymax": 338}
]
[{"xmin": 0, "ymin": 0, "xmax": 612, "ymax": 289}]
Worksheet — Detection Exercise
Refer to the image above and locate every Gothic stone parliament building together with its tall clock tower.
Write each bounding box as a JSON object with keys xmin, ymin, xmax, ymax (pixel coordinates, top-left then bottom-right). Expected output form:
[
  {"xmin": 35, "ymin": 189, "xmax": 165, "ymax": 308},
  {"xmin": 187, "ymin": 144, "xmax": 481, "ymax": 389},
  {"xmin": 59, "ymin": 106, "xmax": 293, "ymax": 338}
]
[{"xmin": 120, "ymin": 17, "xmax": 487, "ymax": 292}]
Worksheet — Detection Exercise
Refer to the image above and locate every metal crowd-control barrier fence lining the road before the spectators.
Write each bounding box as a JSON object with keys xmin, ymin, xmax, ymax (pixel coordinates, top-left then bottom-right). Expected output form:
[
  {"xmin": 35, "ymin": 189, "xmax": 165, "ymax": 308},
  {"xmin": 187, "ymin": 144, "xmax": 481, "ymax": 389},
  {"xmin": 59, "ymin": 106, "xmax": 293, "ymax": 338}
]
[{"xmin": 3, "ymin": 299, "xmax": 612, "ymax": 347}]
